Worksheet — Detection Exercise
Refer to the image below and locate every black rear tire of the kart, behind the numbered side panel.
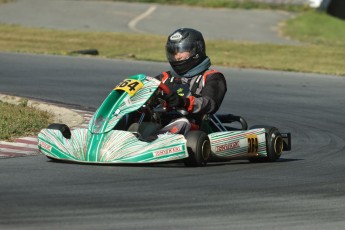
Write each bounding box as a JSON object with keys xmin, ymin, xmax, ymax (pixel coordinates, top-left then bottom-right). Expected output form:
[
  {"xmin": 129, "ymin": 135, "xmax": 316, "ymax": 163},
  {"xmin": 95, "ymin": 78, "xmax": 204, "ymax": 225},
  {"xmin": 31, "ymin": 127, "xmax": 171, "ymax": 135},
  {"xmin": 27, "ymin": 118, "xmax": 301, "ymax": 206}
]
[{"xmin": 249, "ymin": 125, "xmax": 284, "ymax": 163}]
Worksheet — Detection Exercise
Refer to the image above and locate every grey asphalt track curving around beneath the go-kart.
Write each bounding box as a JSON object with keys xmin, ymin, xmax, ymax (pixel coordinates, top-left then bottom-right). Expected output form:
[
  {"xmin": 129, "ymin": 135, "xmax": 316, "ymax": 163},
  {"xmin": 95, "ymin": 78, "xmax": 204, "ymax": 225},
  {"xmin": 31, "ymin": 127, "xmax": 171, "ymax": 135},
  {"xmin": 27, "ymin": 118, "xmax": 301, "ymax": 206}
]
[{"xmin": 0, "ymin": 53, "xmax": 345, "ymax": 229}]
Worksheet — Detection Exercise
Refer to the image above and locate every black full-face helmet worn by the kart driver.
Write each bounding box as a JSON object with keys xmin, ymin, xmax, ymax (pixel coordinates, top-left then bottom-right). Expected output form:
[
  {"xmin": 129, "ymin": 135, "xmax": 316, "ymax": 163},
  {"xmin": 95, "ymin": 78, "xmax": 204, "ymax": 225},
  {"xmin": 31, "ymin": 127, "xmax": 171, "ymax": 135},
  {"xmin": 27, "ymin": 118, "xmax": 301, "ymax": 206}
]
[{"xmin": 165, "ymin": 28, "xmax": 206, "ymax": 75}]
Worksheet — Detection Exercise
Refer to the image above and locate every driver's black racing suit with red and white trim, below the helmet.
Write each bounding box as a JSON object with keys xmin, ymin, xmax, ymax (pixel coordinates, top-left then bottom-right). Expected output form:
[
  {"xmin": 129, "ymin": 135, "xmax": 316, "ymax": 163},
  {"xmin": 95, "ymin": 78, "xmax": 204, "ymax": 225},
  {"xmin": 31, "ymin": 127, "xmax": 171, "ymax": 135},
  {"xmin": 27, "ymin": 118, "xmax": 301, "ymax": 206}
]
[{"xmin": 156, "ymin": 70, "xmax": 227, "ymax": 134}]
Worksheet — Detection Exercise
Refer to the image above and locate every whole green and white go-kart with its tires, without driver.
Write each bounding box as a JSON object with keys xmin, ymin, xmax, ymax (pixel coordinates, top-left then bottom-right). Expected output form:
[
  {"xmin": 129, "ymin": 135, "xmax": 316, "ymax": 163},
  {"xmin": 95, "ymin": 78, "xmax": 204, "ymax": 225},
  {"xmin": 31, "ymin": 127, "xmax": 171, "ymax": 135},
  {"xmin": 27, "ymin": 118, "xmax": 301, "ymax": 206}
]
[{"xmin": 38, "ymin": 74, "xmax": 291, "ymax": 166}]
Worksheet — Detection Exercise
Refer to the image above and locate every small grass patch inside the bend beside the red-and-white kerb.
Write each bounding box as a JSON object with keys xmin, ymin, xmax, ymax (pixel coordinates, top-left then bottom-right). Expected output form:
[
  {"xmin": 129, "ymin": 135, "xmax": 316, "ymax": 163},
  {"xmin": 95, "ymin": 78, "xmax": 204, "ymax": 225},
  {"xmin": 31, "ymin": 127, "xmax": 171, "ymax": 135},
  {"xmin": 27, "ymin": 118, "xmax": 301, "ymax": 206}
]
[{"xmin": 0, "ymin": 100, "xmax": 52, "ymax": 140}]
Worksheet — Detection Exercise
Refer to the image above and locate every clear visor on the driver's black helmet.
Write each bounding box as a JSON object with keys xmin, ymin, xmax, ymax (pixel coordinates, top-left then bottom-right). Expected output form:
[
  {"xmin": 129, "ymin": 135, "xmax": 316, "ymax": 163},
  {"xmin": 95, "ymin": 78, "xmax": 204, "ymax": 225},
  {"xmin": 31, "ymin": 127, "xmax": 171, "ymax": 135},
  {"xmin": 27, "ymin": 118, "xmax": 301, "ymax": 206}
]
[{"xmin": 165, "ymin": 42, "xmax": 196, "ymax": 62}]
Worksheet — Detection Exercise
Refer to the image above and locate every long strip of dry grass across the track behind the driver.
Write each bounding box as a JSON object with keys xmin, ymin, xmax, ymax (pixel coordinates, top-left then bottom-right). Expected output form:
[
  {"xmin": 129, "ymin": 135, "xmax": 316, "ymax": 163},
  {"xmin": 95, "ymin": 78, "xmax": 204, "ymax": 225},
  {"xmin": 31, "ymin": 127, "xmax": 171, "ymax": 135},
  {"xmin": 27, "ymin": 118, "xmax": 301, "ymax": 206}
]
[{"xmin": 0, "ymin": 15, "xmax": 345, "ymax": 76}]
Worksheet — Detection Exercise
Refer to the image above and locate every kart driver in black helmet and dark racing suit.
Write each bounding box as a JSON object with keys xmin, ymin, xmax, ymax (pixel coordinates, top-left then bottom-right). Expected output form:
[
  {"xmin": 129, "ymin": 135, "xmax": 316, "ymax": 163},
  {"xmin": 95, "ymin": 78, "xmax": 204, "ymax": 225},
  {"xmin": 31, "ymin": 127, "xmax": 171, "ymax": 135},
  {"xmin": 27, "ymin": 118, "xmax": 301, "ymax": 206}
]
[{"xmin": 156, "ymin": 28, "xmax": 227, "ymax": 134}]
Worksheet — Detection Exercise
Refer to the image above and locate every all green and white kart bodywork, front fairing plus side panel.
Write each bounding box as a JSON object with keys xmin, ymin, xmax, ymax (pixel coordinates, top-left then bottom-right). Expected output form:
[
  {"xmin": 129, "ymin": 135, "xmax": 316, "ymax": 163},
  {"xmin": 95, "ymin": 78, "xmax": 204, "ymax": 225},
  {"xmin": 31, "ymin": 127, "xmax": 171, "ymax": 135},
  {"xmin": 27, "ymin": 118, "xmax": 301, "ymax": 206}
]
[{"xmin": 38, "ymin": 74, "xmax": 288, "ymax": 164}]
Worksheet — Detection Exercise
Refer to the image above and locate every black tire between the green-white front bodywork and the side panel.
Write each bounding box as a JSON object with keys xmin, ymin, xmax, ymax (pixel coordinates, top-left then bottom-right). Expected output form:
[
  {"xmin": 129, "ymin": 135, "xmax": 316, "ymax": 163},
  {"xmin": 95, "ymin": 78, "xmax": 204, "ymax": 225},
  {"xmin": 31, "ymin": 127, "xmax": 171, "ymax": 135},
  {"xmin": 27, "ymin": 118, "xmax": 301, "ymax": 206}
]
[{"xmin": 184, "ymin": 130, "xmax": 211, "ymax": 167}]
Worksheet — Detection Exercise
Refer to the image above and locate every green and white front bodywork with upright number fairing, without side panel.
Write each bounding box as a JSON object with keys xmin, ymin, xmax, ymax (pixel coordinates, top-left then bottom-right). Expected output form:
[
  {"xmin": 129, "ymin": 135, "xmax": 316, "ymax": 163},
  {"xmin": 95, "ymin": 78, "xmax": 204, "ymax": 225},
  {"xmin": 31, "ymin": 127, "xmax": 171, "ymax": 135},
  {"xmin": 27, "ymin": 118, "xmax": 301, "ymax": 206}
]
[{"xmin": 38, "ymin": 74, "xmax": 188, "ymax": 163}]
